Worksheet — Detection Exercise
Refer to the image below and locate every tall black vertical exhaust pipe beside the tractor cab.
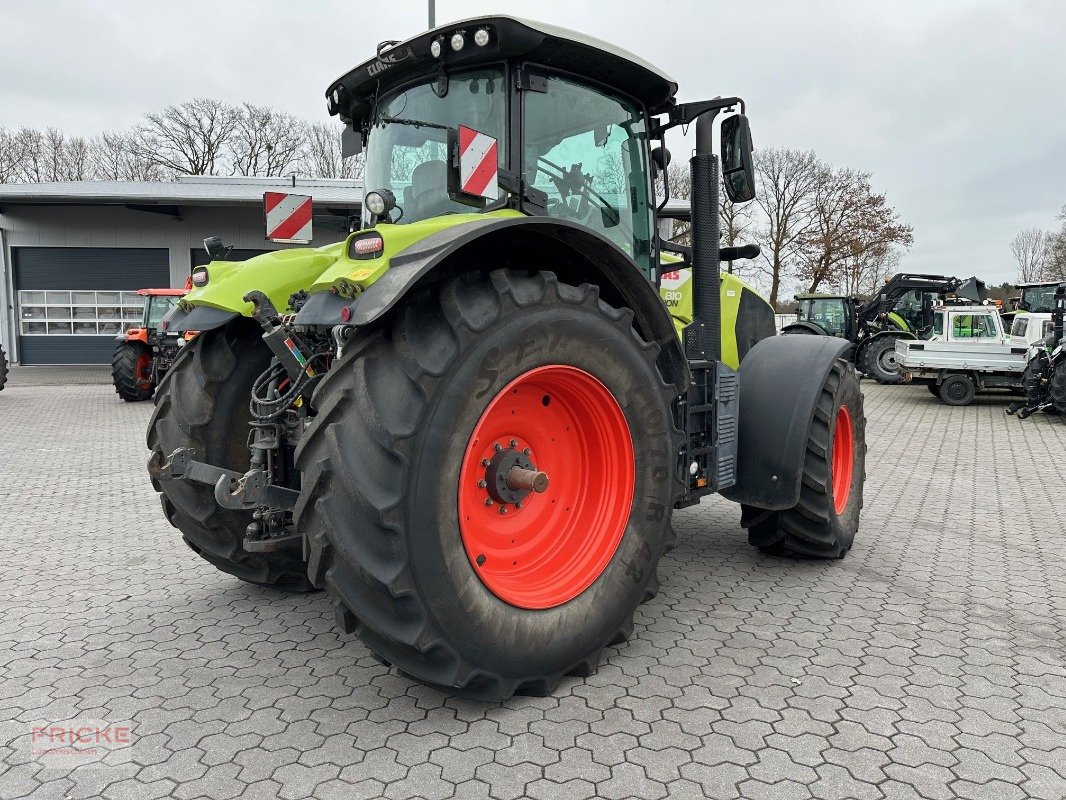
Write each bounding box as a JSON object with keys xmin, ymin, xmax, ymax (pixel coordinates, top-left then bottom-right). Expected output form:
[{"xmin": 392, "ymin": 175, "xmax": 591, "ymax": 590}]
[{"xmin": 685, "ymin": 113, "xmax": 722, "ymax": 361}]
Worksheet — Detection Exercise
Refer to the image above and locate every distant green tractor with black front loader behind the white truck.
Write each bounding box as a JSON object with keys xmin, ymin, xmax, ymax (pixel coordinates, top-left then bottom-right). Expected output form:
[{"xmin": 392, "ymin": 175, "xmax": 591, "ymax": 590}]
[{"xmin": 781, "ymin": 273, "xmax": 987, "ymax": 383}]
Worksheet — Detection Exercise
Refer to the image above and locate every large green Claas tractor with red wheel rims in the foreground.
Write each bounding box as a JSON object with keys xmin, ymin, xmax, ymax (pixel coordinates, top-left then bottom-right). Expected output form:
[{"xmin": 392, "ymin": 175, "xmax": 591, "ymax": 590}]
[{"xmin": 148, "ymin": 16, "xmax": 866, "ymax": 701}]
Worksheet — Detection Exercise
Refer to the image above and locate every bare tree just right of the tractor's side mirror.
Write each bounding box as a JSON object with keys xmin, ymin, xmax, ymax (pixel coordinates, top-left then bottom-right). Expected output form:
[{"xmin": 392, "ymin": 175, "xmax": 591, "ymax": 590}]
[{"xmin": 755, "ymin": 147, "xmax": 821, "ymax": 307}]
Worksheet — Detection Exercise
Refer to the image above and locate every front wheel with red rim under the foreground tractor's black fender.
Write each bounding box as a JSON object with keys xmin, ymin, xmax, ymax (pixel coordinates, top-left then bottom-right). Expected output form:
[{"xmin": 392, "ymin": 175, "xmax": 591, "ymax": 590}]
[{"xmin": 741, "ymin": 358, "xmax": 867, "ymax": 558}]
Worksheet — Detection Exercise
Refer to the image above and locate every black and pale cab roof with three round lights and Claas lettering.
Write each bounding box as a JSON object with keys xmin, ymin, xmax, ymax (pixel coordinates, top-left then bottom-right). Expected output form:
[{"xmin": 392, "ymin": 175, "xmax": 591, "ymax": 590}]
[{"xmin": 326, "ymin": 15, "xmax": 677, "ymax": 121}]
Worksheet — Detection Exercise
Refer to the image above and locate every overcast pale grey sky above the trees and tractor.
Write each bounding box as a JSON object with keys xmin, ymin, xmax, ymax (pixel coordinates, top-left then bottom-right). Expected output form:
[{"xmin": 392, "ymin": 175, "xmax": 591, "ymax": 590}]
[{"xmin": 0, "ymin": 0, "xmax": 1066, "ymax": 283}]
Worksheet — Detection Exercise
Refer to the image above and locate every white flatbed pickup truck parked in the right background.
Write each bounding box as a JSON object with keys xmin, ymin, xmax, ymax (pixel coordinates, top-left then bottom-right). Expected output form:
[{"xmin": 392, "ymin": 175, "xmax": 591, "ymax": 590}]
[{"xmin": 895, "ymin": 305, "xmax": 1052, "ymax": 405}]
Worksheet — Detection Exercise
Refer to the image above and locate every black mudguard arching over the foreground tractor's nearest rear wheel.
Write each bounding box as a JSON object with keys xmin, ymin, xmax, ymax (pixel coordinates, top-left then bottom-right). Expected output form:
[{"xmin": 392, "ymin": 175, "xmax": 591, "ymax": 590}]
[{"xmin": 295, "ymin": 215, "xmax": 690, "ymax": 391}]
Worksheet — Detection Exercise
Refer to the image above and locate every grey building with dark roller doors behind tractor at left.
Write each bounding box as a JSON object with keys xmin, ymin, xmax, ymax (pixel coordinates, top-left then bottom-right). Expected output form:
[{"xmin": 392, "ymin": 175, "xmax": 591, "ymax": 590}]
[{"xmin": 0, "ymin": 176, "xmax": 362, "ymax": 365}]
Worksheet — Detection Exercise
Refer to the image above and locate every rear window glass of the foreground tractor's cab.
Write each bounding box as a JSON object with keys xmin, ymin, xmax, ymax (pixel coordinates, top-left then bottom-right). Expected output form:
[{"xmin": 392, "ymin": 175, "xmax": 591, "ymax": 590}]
[{"xmin": 362, "ymin": 67, "xmax": 507, "ymax": 226}]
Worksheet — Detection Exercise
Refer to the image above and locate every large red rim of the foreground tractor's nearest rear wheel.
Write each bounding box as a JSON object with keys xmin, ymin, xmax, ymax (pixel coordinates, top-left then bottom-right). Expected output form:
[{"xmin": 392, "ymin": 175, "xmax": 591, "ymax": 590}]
[{"xmin": 458, "ymin": 365, "xmax": 635, "ymax": 609}]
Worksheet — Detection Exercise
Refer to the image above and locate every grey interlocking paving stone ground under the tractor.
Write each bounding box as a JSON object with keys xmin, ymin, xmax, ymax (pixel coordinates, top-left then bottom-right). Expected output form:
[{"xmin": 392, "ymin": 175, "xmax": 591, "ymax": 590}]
[{"xmin": 0, "ymin": 368, "xmax": 1066, "ymax": 800}]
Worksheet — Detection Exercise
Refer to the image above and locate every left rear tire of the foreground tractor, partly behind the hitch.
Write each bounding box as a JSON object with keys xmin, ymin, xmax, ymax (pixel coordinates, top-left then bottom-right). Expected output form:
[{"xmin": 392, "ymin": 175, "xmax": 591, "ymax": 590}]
[{"xmin": 148, "ymin": 319, "xmax": 312, "ymax": 591}]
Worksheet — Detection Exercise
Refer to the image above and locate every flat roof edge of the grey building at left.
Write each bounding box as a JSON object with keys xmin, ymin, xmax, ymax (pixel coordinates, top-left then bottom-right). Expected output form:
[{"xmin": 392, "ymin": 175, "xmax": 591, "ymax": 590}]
[{"xmin": 0, "ymin": 175, "xmax": 362, "ymax": 208}]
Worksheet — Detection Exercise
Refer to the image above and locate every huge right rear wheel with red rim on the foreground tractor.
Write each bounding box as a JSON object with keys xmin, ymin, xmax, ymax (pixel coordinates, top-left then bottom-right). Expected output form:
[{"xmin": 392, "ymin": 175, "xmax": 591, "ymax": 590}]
[{"xmin": 295, "ymin": 271, "xmax": 680, "ymax": 701}]
